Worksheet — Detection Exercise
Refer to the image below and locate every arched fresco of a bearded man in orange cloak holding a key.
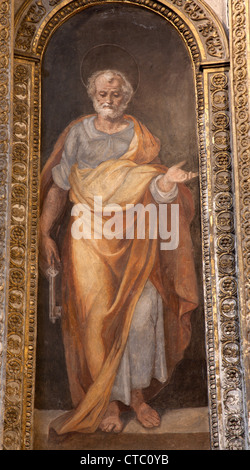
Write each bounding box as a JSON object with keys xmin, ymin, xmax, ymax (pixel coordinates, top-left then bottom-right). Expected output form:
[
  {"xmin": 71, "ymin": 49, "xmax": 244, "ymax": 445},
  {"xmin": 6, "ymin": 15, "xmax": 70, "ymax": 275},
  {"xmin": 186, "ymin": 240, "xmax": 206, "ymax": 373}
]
[{"xmin": 35, "ymin": 5, "xmax": 207, "ymax": 452}]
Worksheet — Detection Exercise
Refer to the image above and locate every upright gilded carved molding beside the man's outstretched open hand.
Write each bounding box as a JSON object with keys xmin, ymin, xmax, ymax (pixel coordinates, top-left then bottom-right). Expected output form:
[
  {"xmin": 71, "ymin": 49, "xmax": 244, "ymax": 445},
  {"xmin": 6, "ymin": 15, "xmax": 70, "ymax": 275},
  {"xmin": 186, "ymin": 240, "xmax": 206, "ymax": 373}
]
[{"xmin": 209, "ymin": 70, "xmax": 247, "ymax": 450}]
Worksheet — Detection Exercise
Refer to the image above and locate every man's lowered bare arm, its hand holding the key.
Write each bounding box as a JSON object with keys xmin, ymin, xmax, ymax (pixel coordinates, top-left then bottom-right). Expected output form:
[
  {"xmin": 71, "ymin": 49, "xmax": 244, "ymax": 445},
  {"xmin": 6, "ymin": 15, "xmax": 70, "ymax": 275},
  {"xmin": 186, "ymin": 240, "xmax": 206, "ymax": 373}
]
[{"xmin": 39, "ymin": 183, "xmax": 68, "ymax": 271}]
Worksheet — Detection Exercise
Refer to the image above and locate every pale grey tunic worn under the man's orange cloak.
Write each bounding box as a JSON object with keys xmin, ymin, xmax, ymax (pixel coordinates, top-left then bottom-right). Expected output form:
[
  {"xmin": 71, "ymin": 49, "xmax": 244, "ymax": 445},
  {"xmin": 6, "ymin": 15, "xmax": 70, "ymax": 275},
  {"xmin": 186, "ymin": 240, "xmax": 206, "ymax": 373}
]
[{"xmin": 52, "ymin": 116, "xmax": 178, "ymax": 405}]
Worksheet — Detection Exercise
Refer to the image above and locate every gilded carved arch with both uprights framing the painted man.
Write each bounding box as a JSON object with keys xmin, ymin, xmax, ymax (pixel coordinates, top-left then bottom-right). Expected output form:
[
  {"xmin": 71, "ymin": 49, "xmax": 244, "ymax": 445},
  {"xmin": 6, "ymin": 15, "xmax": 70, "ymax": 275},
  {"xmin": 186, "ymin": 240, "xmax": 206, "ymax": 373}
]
[{"xmin": 3, "ymin": 0, "xmax": 247, "ymax": 449}]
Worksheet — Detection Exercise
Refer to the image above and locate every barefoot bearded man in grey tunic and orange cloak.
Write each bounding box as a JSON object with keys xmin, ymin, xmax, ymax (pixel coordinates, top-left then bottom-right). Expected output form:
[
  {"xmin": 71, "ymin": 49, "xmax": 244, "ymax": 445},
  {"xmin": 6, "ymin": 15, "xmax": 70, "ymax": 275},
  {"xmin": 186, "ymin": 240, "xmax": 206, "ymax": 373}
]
[{"xmin": 40, "ymin": 70, "xmax": 197, "ymax": 434}]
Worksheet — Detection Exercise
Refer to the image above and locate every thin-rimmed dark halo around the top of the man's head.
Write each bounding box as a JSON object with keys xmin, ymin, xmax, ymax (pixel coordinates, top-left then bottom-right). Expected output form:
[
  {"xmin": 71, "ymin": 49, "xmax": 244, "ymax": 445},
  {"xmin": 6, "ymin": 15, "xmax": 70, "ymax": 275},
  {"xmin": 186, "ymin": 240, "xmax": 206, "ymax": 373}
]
[{"xmin": 80, "ymin": 44, "xmax": 140, "ymax": 93}]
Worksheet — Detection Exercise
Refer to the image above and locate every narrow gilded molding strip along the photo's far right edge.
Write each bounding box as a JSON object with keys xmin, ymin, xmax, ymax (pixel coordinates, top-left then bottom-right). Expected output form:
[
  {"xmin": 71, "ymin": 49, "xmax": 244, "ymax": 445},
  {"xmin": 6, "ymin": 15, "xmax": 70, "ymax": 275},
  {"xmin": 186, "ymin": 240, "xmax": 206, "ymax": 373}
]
[{"xmin": 230, "ymin": 0, "xmax": 250, "ymax": 439}]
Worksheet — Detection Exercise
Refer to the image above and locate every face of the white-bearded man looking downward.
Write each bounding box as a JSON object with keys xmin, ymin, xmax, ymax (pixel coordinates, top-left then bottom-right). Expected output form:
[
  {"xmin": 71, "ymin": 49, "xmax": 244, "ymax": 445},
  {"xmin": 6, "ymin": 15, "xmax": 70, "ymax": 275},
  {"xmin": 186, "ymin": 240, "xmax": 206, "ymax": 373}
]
[{"xmin": 93, "ymin": 75, "xmax": 126, "ymax": 119}]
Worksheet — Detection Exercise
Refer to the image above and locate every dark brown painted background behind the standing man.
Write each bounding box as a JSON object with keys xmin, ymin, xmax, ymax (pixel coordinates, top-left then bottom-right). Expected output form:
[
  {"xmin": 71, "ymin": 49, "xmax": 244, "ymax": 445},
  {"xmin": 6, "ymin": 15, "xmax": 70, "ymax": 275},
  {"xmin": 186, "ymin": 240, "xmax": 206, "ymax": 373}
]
[{"xmin": 35, "ymin": 5, "xmax": 207, "ymax": 409}]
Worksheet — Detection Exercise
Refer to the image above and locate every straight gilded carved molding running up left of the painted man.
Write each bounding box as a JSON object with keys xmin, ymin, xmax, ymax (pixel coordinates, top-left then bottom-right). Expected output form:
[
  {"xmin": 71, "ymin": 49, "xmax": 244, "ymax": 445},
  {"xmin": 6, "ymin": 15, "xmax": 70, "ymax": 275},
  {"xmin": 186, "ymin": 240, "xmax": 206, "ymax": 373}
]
[{"xmin": 3, "ymin": 56, "xmax": 40, "ymax": 450}]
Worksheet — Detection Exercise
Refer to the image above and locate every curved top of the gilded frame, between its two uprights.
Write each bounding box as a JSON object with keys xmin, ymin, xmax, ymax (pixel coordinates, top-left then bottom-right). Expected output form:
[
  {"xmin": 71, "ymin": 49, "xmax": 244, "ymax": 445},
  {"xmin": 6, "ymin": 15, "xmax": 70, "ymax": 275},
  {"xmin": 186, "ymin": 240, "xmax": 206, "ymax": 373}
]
[{"xmin": 15, "ymin": 0, "xmax": 229, "ymax": 64}]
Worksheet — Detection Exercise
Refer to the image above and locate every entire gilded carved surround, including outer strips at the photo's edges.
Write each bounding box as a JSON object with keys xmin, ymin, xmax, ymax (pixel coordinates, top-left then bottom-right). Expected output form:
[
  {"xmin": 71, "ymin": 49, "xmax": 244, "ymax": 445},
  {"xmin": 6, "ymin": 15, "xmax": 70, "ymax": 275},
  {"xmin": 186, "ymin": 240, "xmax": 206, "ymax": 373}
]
[{"xmin": 0, "ymin": 0, "xmax": 250, "ymax": 449}]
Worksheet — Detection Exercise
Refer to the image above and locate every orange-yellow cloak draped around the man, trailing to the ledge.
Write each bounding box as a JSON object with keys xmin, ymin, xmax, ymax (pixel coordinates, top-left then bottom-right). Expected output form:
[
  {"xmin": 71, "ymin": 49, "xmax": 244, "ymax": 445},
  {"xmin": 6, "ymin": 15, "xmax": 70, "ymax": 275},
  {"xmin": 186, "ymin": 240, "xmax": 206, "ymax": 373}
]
[{"xmin": 41, "ymin": 116, "xmax": 198, "ymax": 434}]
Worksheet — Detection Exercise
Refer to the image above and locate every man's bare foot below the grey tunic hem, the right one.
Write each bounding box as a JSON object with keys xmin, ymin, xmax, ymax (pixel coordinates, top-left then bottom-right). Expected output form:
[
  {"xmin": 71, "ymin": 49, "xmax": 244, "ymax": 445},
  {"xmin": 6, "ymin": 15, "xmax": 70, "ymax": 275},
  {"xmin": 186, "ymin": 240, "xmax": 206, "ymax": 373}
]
[{"xmin": 131, "ymin": 390, "xmax": 161, "ymax": 428}]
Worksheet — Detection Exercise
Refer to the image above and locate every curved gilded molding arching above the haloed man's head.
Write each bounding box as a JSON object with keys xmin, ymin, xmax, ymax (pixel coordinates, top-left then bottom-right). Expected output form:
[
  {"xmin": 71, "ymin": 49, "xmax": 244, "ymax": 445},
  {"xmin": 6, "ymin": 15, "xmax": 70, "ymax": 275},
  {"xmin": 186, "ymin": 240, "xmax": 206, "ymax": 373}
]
[{"xmin": 15, "ymin": 0, "xmax": 228, "ymax": 61}]
